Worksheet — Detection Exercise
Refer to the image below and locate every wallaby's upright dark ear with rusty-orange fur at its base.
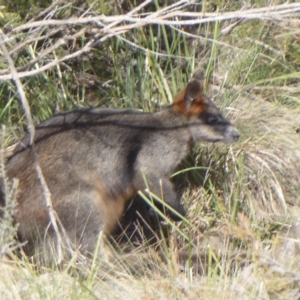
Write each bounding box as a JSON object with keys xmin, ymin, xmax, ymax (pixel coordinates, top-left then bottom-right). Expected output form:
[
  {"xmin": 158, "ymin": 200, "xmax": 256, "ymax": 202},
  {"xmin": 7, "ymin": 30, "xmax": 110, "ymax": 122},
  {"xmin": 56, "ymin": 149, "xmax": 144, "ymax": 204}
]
[{"xmin": 174, "ymin": 69, "xmax": 206, "ymax": 116}]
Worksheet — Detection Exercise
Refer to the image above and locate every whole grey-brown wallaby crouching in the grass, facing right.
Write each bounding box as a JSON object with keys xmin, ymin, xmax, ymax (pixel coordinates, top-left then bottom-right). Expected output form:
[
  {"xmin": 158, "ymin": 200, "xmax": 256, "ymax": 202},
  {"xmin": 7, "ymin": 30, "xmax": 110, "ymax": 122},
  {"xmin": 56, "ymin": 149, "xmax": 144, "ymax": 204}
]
[{"xmin": 0, "ymin": 70, "xmax": 240, "ymax": 253}]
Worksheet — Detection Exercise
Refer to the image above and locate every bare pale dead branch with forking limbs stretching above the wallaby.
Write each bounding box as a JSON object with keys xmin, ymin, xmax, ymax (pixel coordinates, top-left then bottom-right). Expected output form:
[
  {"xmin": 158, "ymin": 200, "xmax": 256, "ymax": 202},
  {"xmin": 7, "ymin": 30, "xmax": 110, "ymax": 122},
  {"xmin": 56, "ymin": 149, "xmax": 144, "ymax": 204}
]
[{"xmin": 0, "ymin": 0, "xmax": 300, "ymax": 80}]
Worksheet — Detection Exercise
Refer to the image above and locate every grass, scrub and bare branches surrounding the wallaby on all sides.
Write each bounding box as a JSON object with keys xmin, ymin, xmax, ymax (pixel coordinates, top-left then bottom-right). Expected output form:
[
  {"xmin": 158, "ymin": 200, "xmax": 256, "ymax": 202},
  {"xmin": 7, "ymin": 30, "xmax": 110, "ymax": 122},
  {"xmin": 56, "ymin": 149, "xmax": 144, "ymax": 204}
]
[{"xmin": 0, "ymin": 0, "xmax": 300, "ymax": 299}]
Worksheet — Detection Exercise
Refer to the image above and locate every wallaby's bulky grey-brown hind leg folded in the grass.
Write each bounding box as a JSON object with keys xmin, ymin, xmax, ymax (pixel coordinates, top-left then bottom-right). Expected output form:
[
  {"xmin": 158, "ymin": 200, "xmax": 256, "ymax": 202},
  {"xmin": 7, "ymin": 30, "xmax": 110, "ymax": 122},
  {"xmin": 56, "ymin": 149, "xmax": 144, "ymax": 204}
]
[{"xmin": 32, "ymin": 184, "xmax": 123, "ymax": 255}]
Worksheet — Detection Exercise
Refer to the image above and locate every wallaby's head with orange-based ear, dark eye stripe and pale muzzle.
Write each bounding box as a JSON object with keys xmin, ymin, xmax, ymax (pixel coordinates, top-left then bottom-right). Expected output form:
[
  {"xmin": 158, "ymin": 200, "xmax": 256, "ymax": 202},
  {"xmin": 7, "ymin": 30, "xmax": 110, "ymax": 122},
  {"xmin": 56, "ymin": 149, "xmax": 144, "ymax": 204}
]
[{"xmin": 174, "ymin": 70, "xmax": 240, "ymax": 144}]
